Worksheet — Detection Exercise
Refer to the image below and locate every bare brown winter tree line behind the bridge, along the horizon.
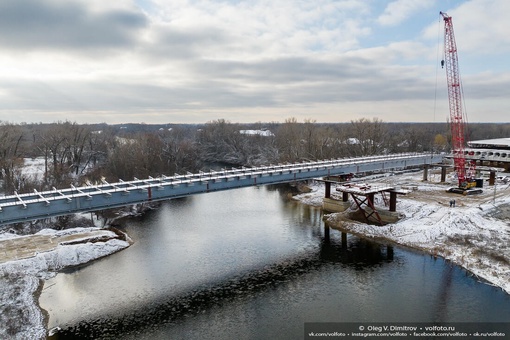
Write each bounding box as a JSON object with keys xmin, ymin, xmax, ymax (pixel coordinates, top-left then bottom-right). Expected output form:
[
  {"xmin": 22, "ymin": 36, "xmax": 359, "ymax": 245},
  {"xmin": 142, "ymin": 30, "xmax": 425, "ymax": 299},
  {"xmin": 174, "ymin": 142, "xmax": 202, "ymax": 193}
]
[{"xmin": 0, "ymin": 118, "xmax": 510, "ymax": 195}]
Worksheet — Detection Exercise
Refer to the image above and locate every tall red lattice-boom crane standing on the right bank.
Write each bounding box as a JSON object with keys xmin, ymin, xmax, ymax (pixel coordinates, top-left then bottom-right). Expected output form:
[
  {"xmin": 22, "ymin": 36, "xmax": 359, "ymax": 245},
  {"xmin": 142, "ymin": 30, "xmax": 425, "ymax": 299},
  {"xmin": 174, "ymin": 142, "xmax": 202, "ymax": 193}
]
[{"xmin": 439, "ymin": 12, "xmax": 475, "ymax": 189}]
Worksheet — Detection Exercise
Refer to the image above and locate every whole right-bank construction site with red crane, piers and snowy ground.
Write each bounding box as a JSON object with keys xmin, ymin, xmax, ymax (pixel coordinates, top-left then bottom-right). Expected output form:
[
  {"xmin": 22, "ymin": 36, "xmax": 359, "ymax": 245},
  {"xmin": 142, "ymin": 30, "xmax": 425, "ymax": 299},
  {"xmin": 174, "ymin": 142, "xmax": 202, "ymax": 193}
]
[{"xmin": 295, "ymin": 12, "xmax": 510, "ymax": 293}]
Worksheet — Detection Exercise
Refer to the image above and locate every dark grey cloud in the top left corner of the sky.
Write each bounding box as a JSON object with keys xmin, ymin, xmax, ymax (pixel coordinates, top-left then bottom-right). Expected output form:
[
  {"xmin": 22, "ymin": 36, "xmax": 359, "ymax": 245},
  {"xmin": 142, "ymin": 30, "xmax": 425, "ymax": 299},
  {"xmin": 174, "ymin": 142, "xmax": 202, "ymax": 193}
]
[{"xmin": 0, "ymin": 0, "xmax": 148, "ymax": 51}]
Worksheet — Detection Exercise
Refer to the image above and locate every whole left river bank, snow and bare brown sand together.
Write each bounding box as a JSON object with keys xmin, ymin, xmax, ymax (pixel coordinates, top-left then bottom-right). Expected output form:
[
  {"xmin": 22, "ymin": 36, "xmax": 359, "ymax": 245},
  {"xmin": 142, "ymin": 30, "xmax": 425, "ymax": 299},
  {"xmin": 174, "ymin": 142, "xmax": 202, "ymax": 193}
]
[{"xmin": 0, "ymin": 228, "xmax": 130, "ymax": 339}]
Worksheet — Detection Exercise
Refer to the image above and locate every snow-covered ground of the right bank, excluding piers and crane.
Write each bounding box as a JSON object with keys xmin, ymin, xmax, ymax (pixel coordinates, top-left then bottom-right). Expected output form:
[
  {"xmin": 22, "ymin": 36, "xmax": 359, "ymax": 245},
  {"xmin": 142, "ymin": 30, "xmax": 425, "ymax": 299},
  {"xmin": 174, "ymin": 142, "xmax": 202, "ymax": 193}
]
[{"xmin": 295, "ymin": 172, "xmax": 510, "ymax": 294}]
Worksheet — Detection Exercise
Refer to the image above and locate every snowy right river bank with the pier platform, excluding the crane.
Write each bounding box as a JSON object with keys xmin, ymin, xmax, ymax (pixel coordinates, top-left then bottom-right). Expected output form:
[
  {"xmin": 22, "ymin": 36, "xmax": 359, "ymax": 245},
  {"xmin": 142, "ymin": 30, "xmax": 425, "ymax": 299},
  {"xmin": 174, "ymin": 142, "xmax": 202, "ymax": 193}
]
[{"xmin": 294, "ymin": 167, "xmax": 510, "ymax": 293}]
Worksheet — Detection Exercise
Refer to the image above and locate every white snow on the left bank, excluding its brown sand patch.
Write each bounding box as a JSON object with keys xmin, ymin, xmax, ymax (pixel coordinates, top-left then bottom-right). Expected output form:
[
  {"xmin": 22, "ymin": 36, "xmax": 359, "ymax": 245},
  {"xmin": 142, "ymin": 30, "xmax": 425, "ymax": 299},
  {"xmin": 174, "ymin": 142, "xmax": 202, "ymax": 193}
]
[{"xmin": 0, "ymin": 228, "xmax": 129, "ymax": 339}]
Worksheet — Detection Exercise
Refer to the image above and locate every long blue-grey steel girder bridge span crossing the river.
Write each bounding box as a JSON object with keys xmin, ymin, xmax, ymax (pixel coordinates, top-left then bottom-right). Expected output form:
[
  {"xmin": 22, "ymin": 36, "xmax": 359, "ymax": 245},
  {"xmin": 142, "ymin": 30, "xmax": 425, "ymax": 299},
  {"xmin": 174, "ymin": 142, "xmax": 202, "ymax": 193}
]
[{"xmin": 0, "ymin": 153, "xmax": 443, "ymax": 227}]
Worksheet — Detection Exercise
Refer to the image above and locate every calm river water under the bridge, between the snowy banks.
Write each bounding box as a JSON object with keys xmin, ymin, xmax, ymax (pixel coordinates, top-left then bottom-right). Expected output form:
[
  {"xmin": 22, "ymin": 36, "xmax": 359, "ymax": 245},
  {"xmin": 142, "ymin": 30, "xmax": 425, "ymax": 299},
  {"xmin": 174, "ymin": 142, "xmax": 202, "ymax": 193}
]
[{"xmin": 39, "ymin": 187, "xmax": 510, "ymax": 340}]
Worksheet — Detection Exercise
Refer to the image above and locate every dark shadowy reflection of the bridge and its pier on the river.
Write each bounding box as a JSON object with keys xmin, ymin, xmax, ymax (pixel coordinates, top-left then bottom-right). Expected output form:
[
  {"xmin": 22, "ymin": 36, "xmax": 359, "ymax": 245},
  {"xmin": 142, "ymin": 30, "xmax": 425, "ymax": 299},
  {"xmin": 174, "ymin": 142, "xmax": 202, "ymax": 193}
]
[{"xmin": 49, "ymin": 234, "xmax": 393, "ymax": 338}]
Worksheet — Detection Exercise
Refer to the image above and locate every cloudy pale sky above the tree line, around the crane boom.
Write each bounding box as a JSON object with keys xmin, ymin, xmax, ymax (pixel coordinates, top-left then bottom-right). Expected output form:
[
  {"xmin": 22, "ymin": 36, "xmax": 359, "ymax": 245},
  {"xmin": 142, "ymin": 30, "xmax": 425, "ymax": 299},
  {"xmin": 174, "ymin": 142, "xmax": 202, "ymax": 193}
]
[{"xmin": 0, "ymin": 0, "xmax": 510, "ymax": 124}]
